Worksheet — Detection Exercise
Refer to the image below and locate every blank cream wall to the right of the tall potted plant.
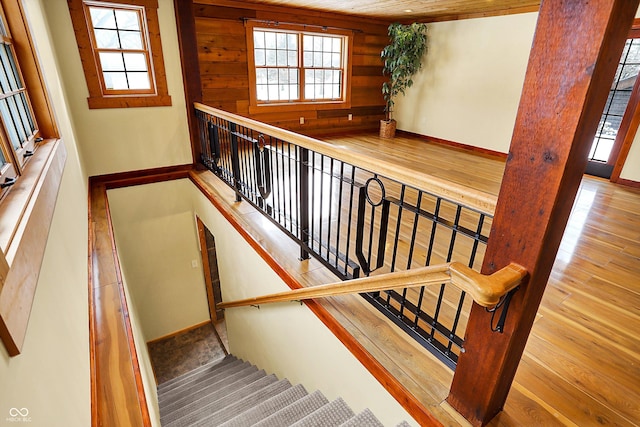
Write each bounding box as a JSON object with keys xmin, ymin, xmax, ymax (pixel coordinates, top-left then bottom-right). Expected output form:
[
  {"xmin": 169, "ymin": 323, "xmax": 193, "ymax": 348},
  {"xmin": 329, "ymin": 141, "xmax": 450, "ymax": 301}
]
[{"xmin": 395, "ymin": 13, "xmax": 538, "ymax": 153}]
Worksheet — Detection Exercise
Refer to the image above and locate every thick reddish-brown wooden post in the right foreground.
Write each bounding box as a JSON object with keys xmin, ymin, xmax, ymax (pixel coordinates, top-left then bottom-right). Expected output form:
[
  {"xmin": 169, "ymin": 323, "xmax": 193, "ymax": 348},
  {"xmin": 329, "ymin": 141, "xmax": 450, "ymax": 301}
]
[{"xmin": 447, "ymin": 0, "xmax": 638, "ymax": 425}]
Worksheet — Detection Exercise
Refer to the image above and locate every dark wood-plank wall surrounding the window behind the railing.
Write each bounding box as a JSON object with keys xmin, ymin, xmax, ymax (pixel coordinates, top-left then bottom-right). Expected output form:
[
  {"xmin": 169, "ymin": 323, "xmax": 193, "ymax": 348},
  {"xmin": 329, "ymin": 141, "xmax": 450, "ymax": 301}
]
[{"xmin": 193, "ymin": 0, "xmax": 388, "ymax": 135}]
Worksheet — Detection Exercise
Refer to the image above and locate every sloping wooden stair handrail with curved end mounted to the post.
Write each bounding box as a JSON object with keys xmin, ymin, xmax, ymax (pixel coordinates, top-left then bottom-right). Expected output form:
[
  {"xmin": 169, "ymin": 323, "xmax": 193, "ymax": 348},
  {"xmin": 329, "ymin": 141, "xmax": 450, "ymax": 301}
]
[{"xmin": 217, "ymin": 262, "xmax": 527, "ymax": 308}]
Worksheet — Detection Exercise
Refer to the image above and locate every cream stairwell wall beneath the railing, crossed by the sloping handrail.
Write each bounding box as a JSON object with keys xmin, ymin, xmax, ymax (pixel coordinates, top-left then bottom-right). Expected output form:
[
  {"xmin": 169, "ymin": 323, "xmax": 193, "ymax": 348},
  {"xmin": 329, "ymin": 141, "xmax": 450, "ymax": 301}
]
[{"xmin": 190, "ymin": 185, "xmax": 415, "ymax": 426}]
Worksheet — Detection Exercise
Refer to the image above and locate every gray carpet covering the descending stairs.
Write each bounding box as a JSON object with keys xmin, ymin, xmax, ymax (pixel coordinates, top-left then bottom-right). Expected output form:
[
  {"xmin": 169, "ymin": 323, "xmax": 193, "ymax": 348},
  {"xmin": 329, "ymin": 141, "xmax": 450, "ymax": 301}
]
[{"xmin": 158, "ymin": 355, "xmax": 408, "ymax": 427}]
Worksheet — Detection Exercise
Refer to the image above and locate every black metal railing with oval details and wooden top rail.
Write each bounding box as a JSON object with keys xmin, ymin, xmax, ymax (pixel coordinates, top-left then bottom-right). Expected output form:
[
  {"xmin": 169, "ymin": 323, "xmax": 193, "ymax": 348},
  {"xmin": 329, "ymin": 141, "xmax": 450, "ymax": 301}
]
[{"xmin": 196, "ymin": 104, "xmax": 495, "ymax": 368}]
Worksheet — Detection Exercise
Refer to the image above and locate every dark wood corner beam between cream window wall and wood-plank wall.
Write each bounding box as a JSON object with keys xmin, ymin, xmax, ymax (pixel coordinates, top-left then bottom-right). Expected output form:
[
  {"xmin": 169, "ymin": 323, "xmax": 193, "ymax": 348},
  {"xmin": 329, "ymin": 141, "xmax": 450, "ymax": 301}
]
[{"xmin": 173, "ymin": 0, "xmax": 202, "ymax": 165}]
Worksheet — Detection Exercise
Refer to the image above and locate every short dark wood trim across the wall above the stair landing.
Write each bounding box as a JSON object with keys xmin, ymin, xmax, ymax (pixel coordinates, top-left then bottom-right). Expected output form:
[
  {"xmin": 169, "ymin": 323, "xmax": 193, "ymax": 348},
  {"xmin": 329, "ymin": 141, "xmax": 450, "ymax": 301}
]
[{"xmin": 89, "ymin": 164, "xmax": 194, "ymax": 190}]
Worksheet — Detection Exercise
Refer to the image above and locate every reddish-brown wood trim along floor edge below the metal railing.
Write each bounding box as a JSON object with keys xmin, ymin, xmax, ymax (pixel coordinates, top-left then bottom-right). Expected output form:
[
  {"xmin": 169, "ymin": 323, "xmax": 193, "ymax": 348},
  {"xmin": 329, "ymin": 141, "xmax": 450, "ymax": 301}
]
[{"xmin": 189, "ymin": 171, "xmax": 442, "ymax": 426}]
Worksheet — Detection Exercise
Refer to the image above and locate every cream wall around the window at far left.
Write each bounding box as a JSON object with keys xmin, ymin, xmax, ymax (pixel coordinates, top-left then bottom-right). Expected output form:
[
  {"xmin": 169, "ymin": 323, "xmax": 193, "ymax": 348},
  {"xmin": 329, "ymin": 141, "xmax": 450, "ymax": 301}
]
[{"xmin": 0, "ymin": 0, "xmax": 91, "ymax": 427}]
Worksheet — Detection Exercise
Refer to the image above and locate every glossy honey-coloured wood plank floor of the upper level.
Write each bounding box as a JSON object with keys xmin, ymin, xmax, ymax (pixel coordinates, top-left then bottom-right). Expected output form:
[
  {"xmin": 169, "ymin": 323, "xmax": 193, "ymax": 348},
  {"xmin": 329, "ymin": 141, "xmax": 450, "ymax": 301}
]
[{"xmin": 201, "ymin": 132, "xmax": 640, "ymax": 426}]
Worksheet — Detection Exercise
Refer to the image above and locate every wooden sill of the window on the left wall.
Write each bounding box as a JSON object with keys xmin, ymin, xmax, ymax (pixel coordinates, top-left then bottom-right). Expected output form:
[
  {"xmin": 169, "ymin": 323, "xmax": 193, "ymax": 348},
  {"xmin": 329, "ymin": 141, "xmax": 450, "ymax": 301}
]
[{"xmin": 0, "ymin": 139, "xmax": 67, "ymax": 356}]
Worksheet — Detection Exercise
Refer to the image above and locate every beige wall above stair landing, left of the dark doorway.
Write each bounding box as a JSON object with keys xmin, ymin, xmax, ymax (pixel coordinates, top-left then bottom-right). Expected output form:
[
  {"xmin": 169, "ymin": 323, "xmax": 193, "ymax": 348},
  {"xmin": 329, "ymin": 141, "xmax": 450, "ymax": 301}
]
[{"xmin": 108, "ymin": 180, "xmax": 209, "ymax": 342}]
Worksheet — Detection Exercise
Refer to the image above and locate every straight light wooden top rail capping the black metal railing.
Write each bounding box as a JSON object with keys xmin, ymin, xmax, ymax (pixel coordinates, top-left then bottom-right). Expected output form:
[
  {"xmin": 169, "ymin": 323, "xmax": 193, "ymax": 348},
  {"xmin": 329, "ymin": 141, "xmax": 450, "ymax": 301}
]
[{"xmin": 194, "ymin": 102, "xmax": 497, "ymax": 216}]
